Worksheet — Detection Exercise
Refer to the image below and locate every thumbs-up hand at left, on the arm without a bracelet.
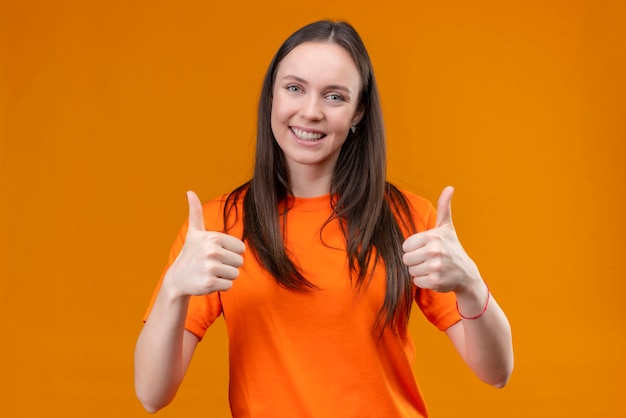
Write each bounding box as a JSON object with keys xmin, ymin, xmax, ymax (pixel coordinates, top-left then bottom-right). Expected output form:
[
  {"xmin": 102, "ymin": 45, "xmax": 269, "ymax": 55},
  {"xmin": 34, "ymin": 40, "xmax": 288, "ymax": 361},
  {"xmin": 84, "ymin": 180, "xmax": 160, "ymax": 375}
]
[{"xmin": 164, "ymin": 191, "xmax": 245, "ymax": 296}]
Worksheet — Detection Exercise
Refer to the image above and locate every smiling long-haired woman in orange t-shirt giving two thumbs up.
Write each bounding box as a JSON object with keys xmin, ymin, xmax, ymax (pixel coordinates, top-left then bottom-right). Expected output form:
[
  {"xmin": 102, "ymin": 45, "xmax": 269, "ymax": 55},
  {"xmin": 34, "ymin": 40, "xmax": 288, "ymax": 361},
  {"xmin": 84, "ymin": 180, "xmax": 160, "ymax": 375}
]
[{"xmin": 135, "ymin": 21, "xmax": 513, "ymax": 418}]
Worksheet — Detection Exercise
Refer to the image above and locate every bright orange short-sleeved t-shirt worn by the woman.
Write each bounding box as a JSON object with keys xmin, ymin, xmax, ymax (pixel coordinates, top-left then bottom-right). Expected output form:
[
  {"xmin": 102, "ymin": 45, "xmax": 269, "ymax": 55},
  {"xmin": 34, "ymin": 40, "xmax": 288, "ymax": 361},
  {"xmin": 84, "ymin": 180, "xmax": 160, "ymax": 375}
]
[{"xmin": 145, "ymin": 192, "xmax": 460, "ymax": 418}]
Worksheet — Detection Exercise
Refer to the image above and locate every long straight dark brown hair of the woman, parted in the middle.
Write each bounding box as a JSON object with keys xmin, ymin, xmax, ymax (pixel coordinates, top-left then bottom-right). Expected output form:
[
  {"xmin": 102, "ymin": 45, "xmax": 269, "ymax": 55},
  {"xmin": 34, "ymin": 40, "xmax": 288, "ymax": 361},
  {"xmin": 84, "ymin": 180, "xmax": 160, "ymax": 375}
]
[{"xmin": 224, "ymin": 20, "xmax": 415, "ymax": 331}]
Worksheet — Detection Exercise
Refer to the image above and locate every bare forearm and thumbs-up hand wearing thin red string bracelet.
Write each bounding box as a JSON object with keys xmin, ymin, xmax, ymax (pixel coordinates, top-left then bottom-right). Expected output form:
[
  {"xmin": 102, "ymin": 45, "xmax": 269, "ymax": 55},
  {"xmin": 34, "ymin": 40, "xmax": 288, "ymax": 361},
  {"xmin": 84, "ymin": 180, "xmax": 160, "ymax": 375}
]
[{"xmin": 403, "ymin": 187, "xmax": 513, "ymax": 387}]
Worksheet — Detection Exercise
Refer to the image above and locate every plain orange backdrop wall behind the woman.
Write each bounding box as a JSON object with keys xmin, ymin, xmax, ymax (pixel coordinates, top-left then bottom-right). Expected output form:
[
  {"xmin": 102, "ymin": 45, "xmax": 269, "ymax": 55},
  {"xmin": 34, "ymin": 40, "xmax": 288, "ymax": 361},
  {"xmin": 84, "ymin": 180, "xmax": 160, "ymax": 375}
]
[{"xmin": 0, "ymin": 0, "xmax": 626, "ymax": 417}]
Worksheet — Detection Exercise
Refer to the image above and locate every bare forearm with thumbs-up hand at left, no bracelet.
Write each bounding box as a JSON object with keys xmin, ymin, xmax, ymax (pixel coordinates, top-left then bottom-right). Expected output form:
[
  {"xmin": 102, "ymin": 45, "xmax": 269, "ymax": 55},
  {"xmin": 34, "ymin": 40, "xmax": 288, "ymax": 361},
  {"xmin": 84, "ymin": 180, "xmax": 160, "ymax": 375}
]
[{"xmin": 135, "ymin": 192, "xmax": 245, "ymax": 412}]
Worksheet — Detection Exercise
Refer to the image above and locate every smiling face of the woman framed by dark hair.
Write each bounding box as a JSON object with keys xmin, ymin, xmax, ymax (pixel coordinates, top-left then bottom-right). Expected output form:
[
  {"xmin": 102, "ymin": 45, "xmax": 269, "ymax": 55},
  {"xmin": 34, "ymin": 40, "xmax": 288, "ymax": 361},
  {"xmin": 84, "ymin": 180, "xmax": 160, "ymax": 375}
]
[{"xmin": 271, "ymin": 42, "xmax": 362, "ymax": 188}]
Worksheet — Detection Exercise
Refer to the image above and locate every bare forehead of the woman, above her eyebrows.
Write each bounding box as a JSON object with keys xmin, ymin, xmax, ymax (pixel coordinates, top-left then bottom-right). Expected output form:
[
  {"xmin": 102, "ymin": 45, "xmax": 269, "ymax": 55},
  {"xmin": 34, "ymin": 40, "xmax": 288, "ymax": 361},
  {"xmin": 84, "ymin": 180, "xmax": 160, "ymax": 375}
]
[{"xmin": 276, "ymin": 42, "xmax": 361, "ymax": 90}]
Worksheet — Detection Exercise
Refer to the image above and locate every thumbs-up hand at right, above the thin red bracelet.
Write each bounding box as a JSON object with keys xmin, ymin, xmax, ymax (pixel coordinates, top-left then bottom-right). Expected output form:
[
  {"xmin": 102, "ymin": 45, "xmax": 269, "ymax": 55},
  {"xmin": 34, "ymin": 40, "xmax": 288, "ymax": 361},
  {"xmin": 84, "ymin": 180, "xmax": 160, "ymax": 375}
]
[{"xmin": 402, "ymin": 186, "xmax": 482, "ymax": 292}]
